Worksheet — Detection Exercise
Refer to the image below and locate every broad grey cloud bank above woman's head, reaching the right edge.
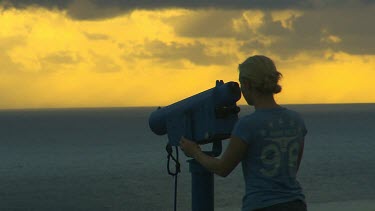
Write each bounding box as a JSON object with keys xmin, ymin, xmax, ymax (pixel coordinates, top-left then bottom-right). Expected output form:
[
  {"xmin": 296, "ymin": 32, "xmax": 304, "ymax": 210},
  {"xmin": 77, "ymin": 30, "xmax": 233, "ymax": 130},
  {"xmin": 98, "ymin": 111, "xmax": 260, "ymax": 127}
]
[{"xmin": 165, "ymin": 5, "xmax": 375, "ymax": 59}]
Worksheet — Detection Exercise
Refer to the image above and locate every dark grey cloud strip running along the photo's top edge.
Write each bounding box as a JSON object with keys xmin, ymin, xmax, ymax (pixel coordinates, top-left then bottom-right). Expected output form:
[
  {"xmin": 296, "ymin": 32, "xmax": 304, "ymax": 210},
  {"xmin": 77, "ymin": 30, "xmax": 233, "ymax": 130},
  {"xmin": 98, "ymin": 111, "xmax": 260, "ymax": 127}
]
[{"xmin": 0, "ymin": 0, "xmax": 375, "ymax": 19}]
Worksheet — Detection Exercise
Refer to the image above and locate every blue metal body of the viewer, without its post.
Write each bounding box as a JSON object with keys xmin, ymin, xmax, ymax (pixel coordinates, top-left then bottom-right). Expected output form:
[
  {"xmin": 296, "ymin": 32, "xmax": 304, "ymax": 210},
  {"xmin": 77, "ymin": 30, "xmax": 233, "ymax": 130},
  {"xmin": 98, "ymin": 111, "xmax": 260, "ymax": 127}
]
[{"xmin": 149, "ymin": 81, "xmax": 241, "ymax": 146}]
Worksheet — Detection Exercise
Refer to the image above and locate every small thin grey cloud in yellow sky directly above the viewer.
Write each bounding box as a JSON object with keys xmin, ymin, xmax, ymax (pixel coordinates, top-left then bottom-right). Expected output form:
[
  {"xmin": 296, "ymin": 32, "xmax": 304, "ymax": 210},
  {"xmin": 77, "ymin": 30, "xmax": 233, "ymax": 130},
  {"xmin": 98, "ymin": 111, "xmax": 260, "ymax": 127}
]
[{"xmin": 131, "ymin": 40, "xmax": 237, "ymax": 65}]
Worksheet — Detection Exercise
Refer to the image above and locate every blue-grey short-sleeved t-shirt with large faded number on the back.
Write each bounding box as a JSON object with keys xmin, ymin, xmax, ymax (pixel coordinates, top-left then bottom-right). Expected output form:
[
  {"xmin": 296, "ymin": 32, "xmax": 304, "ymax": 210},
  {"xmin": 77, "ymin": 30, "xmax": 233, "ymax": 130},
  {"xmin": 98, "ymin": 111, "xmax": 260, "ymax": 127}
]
[{"xmin": 232, "ymin": 107, "xmax": 307, "ymax": 211}]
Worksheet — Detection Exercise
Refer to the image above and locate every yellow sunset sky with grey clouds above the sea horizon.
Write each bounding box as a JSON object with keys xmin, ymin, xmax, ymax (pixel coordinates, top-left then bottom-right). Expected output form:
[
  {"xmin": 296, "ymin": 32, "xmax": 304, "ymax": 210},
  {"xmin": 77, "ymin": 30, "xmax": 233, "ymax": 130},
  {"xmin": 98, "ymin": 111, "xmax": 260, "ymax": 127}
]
[{"xmin": 0, "ymin": 0, "xmax": 375, "ymax": 109}]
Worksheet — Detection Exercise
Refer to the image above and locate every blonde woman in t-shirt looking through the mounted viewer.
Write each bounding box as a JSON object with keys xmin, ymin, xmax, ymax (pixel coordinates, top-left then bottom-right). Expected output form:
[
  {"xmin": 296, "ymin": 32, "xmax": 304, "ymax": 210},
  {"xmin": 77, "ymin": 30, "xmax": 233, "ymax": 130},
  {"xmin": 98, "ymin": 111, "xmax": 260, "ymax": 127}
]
[{"xmin": 180, "ymin": 55, "xmax": 307, "ymax": 211}]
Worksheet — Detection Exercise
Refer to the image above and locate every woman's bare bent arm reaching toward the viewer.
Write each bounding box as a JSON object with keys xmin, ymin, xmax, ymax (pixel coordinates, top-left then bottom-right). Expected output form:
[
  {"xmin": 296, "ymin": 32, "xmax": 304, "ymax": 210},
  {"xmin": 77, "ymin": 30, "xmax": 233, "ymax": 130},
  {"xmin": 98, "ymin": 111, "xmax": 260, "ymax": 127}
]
[{"xmin": 180, "ymin": 137, "xmax": 248, "ymax": 177}]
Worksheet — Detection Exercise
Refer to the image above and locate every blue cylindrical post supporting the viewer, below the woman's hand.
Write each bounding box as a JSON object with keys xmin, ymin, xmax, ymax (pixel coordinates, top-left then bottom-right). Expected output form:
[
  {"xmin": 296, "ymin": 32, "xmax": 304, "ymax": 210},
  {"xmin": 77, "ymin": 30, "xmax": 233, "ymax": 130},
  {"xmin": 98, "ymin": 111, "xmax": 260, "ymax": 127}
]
[{"xmin": 188, "ymin": 159, "xmax": 214, "ymax": 211}]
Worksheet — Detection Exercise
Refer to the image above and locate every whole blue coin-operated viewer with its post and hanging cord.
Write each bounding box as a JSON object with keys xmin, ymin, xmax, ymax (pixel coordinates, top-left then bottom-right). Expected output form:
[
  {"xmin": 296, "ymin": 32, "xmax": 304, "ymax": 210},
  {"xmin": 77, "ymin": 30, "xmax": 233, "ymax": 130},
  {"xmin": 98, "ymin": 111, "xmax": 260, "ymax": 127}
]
[{"xmin": 149, "ymin": 80, "xmax": 241, "ymax": 211}]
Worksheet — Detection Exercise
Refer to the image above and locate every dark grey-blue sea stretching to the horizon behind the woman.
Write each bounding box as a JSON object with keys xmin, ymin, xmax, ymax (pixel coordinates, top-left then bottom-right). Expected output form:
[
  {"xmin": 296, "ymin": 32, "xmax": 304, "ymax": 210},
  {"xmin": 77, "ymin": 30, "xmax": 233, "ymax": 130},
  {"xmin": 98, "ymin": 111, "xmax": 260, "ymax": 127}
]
[{"xmin": 0, "ymin": 104, "xmax": 375, "ymax": 211}]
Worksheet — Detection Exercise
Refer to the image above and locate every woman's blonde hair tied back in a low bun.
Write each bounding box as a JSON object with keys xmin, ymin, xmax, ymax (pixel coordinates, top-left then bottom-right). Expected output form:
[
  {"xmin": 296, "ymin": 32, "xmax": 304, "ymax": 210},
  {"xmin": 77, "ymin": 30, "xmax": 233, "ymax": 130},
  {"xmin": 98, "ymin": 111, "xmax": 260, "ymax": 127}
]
[{"xmin": 238, "ymin": 55, "xmax": 282, "ymax": 94}]
